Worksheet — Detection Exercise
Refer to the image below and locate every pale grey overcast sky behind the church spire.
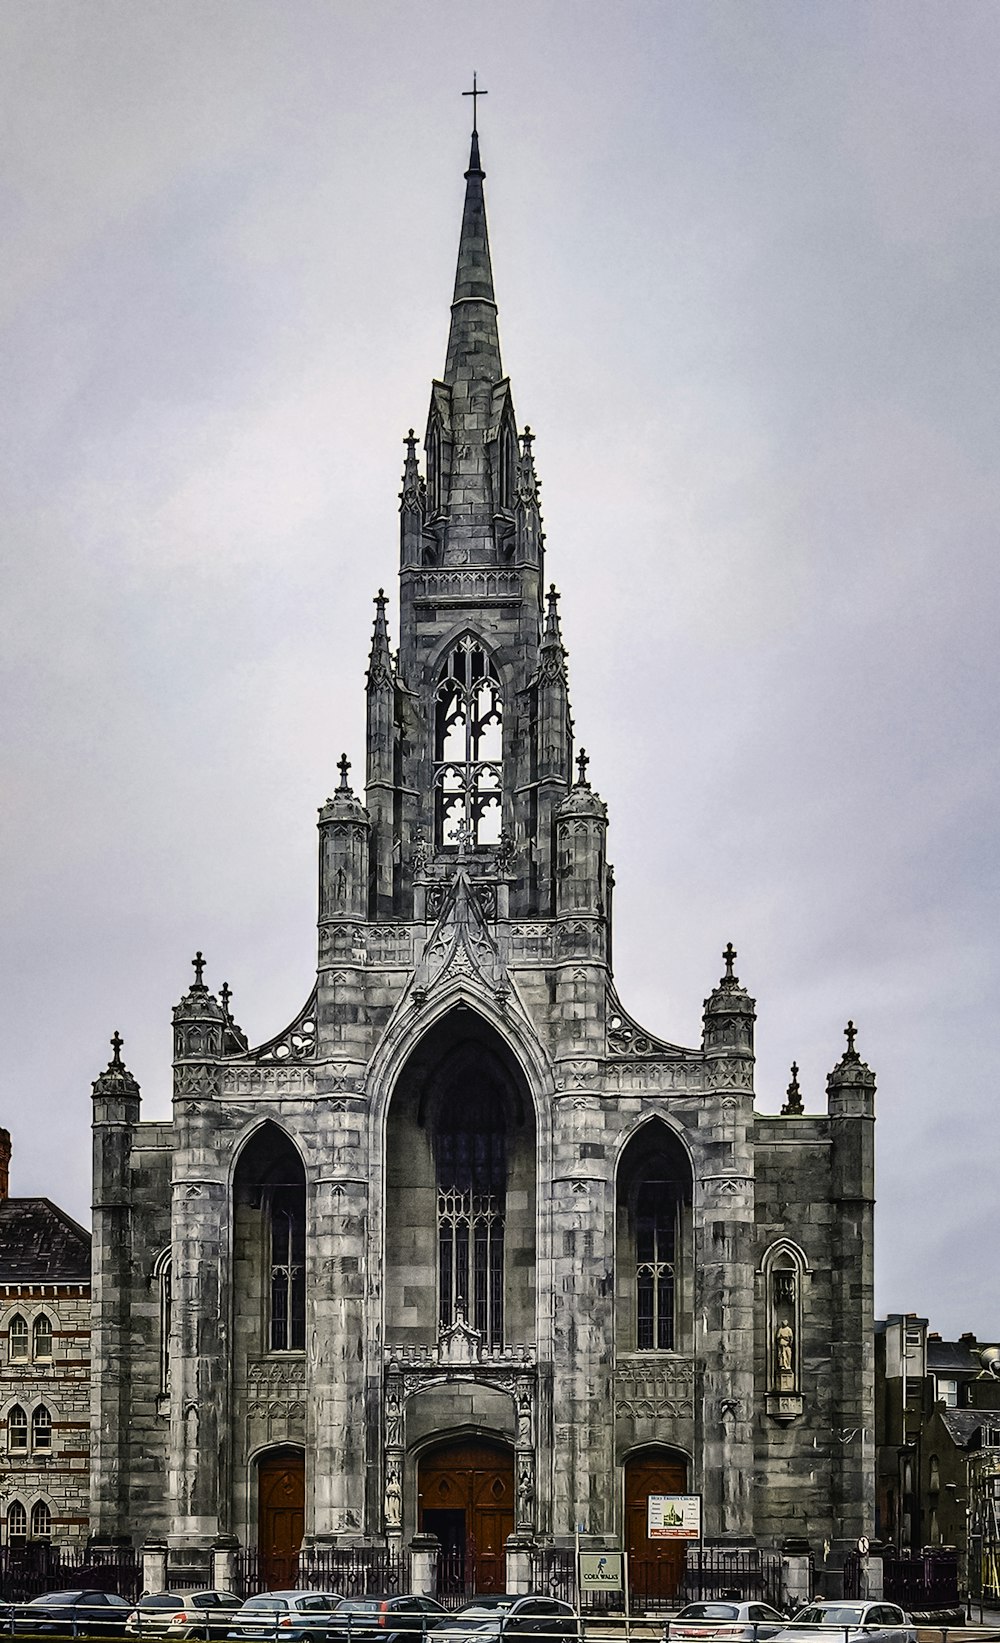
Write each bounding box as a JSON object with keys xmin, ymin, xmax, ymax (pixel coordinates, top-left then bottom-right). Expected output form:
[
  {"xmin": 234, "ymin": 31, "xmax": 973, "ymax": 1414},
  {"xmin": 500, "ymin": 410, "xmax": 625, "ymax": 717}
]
[{"xmin": 0, "ymin": 0, "xmax": 1000, "ymax": 1339}]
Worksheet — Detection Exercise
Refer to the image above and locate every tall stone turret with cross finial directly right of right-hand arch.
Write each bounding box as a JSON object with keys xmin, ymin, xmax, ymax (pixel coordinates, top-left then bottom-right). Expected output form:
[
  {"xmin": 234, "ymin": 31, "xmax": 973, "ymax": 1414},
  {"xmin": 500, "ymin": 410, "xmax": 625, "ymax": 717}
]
[{"xmin": 695, "ymin": 945, "xmax": 755, "ymax": 1541}]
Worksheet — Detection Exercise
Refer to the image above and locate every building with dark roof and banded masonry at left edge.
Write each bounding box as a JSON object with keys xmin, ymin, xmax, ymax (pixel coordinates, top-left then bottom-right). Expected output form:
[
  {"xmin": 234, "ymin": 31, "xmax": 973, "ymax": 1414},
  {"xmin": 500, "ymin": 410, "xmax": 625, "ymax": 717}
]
[{"xmin": 0, "ymin": 1130, "xmax": 90, "ymax": 1553}]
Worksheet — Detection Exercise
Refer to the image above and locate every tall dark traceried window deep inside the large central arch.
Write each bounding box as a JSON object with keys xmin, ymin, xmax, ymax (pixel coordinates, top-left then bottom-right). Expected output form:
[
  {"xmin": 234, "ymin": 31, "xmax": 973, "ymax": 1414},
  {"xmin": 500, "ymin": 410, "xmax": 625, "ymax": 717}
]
[{"xmin": 435, "ymin": 1083, "xmax": 507, "ymax": 1347}]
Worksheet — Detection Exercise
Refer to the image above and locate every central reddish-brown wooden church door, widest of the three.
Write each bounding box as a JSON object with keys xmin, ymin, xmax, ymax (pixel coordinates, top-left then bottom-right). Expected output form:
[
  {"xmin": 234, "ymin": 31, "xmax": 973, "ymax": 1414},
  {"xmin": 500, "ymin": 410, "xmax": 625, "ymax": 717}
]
[{"xmin": 417, "ymin": 1438, "xmax": 514, "ymax": 1592}]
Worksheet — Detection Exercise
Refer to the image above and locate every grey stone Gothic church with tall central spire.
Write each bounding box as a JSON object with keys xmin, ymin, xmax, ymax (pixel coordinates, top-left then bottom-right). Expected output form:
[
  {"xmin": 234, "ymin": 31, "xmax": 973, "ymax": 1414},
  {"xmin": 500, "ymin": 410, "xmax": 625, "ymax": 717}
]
[{"xmin": 90, "ymin": 135, "xmax": 874, "ymax": 1589}]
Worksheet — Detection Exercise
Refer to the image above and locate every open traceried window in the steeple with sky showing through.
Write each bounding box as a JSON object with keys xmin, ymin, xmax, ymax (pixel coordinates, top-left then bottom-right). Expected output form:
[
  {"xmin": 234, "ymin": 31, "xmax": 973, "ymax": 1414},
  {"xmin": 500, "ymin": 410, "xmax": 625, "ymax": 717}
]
[{"xmin": 433, "ymin": 634, "xmax": 504, "ymax": 849}]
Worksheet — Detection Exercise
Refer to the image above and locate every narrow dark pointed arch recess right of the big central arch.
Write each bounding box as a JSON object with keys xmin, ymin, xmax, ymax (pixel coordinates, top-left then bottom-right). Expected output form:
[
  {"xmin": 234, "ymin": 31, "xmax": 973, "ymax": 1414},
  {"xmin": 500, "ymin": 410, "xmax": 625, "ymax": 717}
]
[{"xmin": 614, "ymin": 1117, "xmax": 693, "ymax": 1352}]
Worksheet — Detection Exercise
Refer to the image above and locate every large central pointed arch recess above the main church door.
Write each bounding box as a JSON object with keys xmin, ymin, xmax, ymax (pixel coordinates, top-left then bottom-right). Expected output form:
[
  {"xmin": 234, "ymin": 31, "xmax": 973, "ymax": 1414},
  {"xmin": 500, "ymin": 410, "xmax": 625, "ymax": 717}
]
[{"xmin": 384, "ymin": 1007, "xmax": 535, "ymax": 1355}]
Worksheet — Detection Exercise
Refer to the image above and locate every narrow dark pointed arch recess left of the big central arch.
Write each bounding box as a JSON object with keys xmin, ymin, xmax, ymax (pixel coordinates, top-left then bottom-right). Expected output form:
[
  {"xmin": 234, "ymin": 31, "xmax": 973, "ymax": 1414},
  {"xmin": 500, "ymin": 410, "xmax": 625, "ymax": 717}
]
[{"xmin": 233, "ymin": 1121, "xmax": 305, "ymax": 1354}]
